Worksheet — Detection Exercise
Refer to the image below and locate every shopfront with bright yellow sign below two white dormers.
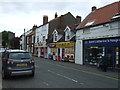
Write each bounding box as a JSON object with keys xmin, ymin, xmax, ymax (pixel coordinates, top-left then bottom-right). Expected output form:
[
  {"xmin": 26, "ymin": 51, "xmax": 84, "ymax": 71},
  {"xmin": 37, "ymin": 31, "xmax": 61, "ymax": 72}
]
[{"xmin": 48, "ymin": 42, "xmax": 74, "ymax": 61}]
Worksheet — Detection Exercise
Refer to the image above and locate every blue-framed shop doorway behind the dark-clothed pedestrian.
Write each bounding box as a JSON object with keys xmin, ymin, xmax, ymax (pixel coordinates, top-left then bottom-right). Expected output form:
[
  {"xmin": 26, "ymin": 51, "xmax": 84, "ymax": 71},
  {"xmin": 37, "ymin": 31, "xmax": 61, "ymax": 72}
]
[{"xmin": 105, "ymin": 47, "xmax": 115, "ymax": 67}]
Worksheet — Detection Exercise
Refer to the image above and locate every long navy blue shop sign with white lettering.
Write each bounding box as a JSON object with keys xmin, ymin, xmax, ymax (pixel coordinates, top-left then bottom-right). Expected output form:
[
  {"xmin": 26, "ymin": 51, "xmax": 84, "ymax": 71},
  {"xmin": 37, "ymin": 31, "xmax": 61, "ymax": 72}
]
[{"xmin": 84, "ymin": 38, "xmax": 120, "ymax": 46}]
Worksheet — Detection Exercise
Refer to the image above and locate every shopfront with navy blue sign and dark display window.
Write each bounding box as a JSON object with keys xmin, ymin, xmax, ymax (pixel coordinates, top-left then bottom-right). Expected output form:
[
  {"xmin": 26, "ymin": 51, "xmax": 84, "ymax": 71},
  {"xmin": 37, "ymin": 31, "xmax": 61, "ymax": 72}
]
[{"xmin": 83, "ymin": 37, "xmax": 120, "ymax": 69}]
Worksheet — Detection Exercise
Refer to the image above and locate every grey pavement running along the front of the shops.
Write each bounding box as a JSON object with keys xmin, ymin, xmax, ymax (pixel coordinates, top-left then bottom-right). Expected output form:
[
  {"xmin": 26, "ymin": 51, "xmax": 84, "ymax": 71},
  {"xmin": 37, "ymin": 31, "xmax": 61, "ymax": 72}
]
[{"xmin": 35, "ymin": 57, "xmax": 120, "ymax": 80}]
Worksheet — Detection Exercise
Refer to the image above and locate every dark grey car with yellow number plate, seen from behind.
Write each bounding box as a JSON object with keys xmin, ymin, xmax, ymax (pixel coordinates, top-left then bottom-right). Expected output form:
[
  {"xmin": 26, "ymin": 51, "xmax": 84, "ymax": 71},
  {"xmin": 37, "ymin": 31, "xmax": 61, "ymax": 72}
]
[{"xmin": 2, "ymin": 50, "xmax": 35, "ymax": 79}]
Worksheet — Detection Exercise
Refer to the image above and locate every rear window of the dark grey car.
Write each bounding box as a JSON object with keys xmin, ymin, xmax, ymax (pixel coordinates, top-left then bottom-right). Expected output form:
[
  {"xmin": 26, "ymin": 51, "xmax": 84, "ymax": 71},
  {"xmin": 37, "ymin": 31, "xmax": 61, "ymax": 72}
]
[{"xmin": 9, "ymin": 52, "xmax": 32, "ymax": 60}]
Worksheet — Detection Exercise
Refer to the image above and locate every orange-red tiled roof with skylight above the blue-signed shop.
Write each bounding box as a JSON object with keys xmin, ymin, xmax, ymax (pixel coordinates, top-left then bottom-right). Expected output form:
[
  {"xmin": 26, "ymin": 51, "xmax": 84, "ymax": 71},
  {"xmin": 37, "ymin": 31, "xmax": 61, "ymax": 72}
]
[{"xmin": 77, "ymin": 1, "xmax": 120, "ymax": 29}]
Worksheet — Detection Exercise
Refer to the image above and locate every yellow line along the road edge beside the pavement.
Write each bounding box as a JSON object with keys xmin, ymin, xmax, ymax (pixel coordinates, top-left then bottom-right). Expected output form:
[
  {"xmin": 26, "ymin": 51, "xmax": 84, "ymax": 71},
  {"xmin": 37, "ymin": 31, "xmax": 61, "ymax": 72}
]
[{"xmin": 46, "ymin": 62, "xmax": 120, "ymax": 80}]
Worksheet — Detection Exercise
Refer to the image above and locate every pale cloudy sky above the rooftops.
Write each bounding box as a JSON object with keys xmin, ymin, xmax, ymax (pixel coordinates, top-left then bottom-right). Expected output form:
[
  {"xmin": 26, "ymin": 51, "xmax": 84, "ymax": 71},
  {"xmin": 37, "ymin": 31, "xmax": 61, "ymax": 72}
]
[{"xmin": 0, "ymin": 0, "xmax": 119, "ymax": 37}]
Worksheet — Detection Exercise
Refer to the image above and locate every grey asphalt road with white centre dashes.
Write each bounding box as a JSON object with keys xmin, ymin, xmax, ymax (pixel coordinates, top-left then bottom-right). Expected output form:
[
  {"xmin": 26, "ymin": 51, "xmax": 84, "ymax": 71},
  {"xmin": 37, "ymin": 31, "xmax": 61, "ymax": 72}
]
[{"xmin": 2, "ymin": 57, "xmax": 118, "ymax": 88}]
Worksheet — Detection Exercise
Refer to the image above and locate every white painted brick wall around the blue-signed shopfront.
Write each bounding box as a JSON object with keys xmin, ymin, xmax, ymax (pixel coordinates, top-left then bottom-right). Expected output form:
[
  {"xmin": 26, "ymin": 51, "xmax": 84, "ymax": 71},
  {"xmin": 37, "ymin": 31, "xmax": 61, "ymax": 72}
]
[{"xmin": 75, "ymin": 21, "xmax": 120, "ymax": 64}]
